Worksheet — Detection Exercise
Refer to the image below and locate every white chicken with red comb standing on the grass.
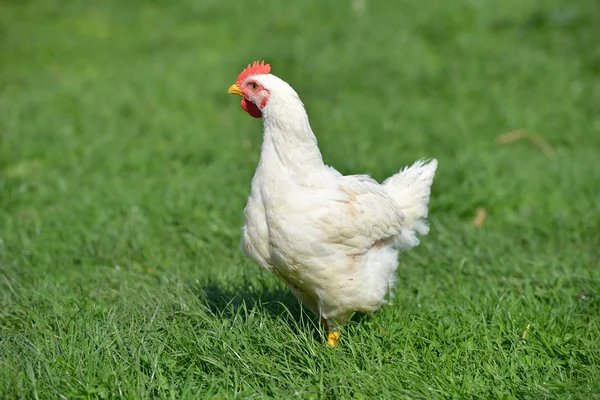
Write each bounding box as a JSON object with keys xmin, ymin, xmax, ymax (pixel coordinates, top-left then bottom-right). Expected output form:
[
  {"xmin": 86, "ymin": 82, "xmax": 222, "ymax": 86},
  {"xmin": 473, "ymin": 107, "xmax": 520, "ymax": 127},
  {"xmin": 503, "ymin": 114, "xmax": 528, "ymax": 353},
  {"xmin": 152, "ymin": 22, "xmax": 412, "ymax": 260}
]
[{"xmin": 229, "ymin": 62, "xmax": 437, "ymax": 346}]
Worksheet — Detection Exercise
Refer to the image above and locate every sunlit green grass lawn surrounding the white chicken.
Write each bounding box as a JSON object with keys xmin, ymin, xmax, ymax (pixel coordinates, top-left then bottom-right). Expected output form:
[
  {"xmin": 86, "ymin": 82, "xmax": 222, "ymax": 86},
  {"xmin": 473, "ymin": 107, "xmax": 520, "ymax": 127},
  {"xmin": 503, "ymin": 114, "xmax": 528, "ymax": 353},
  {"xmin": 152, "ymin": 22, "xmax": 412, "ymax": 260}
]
[{"xmin": 0, "ymin": 0, "xmax": 600, "ymax": 399}]
